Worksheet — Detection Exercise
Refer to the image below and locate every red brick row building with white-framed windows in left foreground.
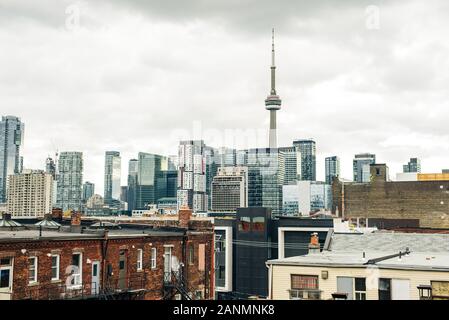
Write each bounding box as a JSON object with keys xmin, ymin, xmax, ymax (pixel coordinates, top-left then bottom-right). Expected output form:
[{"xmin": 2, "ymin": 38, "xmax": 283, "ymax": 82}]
[{"xmin": 0, "ymin": 210, "xmax": 214, "ymax": 300}]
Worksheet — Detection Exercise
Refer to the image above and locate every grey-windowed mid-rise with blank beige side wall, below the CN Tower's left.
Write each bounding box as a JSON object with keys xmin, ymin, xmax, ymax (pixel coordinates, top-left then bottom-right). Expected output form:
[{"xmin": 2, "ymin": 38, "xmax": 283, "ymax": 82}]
[{"xmin": 211, "ymin": 167, "xmax": 248, "ymax": 212}]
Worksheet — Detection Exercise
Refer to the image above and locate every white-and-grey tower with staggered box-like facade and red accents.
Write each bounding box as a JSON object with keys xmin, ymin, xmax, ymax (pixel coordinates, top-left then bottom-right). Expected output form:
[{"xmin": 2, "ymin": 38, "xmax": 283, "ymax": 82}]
[{"xmin": 177, "ymin": 140, "xmax": 210, "ymax": 213}]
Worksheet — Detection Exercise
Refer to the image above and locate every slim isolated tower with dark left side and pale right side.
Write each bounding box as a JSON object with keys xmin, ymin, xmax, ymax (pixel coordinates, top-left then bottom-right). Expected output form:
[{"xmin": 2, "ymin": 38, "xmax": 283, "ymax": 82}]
[{"xmin": 104, "ymin": 151, "xmax": 122, "ymax": 204}]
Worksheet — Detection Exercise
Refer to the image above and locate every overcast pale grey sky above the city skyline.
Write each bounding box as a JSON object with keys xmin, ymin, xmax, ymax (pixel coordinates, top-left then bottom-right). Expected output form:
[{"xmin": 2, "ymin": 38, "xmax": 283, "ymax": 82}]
[{"xmin": 0, "ymin": 0, "xmax": 449, "ymax": 194}]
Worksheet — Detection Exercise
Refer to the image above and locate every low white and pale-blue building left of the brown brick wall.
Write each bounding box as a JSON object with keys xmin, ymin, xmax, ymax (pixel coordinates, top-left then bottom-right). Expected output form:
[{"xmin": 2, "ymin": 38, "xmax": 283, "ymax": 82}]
[{"xmin": 282, "ymin": 181, "xmax": 332, "ymax": 217}]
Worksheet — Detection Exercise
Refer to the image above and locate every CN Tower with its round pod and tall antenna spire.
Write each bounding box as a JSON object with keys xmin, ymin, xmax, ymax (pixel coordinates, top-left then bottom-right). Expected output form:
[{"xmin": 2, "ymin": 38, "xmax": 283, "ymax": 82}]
[{"xmin": 265, "ymin": 28, "xmax": 281, "ymax": 149}]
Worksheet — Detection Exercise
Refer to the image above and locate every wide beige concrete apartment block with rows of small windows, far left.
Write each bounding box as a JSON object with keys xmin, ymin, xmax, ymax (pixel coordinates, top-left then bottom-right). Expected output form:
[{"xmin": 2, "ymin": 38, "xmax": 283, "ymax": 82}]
[{"xmin": 7, "ymin": 170, "xmax": 53, "ymax": 218}]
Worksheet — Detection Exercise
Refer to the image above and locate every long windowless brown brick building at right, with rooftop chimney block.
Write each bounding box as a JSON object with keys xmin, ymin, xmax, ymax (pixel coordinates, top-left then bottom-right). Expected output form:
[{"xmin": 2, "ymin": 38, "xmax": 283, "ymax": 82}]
[{"xmin": 332, "ymin": 164, "xmax": 449, "ymax": 228}]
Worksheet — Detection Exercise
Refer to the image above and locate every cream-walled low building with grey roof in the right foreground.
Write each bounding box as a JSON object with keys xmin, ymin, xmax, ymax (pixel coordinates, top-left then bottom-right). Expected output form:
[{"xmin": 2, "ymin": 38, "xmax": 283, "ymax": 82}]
[{"xmin": 267, "ymin": 232, "xmax": 449, "ymax": 300}]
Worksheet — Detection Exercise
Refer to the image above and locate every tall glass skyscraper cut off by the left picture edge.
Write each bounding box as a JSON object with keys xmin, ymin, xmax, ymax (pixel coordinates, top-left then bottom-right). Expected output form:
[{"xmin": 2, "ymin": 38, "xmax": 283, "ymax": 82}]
[{"xmin": 0, "ymin": 116, "xmax": 25, "ymax": 203}]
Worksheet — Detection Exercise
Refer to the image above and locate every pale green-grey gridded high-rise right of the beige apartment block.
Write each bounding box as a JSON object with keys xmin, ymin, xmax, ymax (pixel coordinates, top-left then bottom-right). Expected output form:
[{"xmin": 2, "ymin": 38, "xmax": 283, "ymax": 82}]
[{"xmin": 56, "ymin": 152, "xmax": 83, "ymax": 211}]
